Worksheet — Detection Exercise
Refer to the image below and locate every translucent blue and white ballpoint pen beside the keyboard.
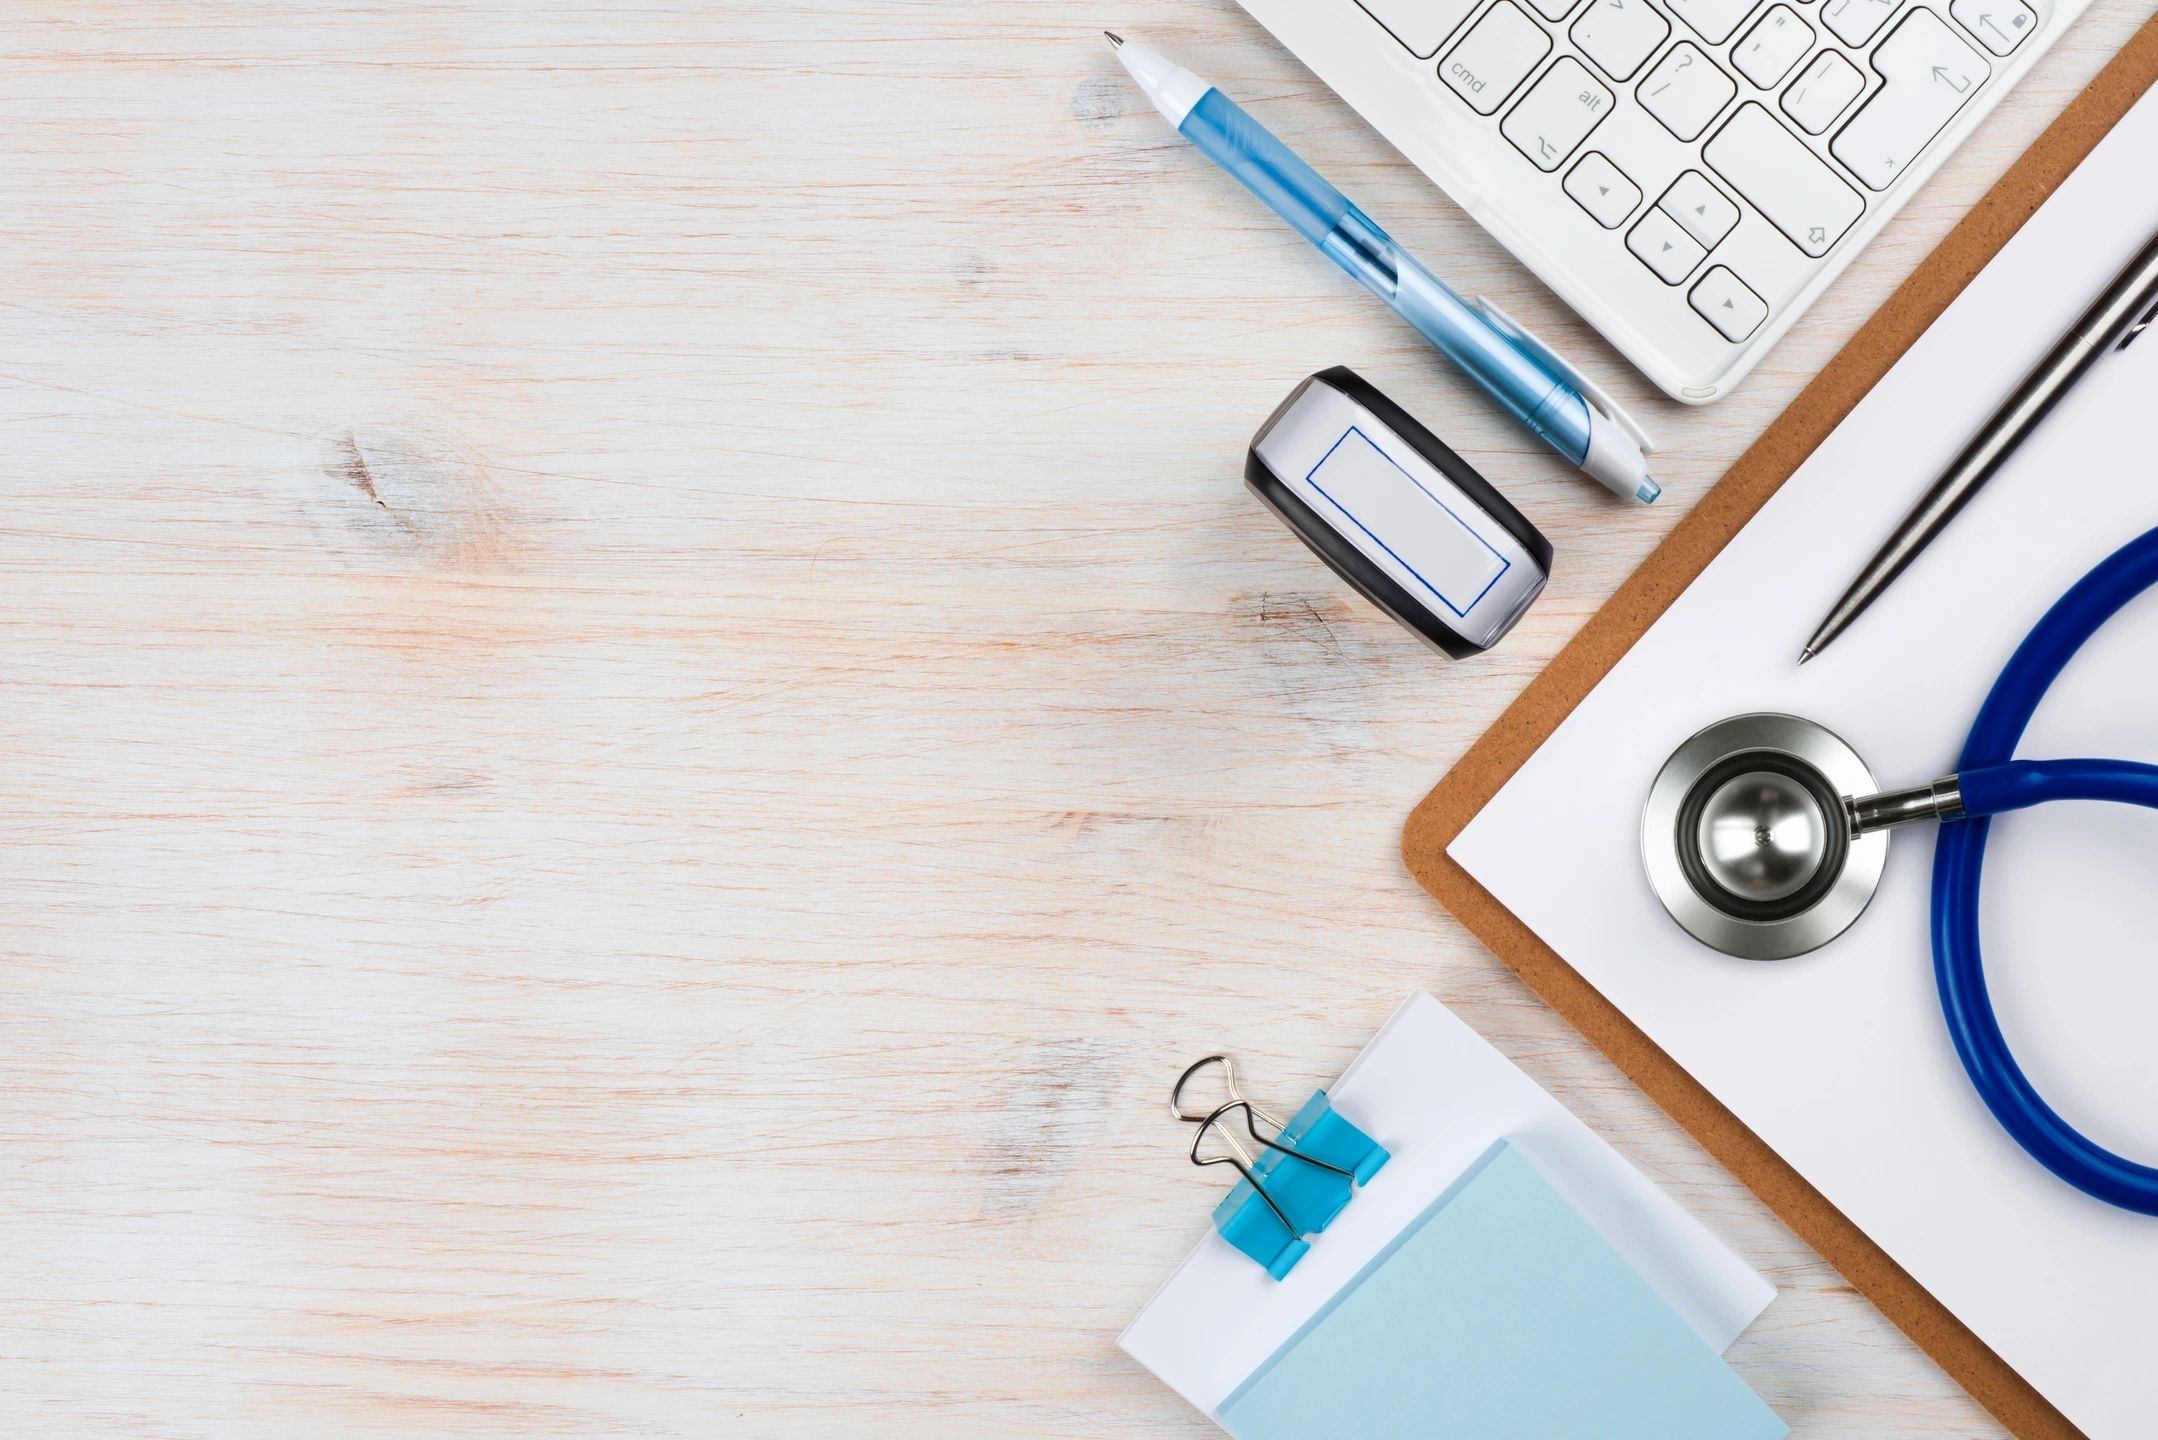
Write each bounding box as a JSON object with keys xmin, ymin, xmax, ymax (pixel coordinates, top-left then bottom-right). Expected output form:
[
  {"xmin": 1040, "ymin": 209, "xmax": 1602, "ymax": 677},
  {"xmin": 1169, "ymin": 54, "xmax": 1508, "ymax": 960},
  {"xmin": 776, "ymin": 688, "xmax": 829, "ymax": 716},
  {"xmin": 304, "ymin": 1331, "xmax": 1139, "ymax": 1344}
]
[{"xmin": 1105, "ymin": 30, "xmax": 1662, "ymax": 503}]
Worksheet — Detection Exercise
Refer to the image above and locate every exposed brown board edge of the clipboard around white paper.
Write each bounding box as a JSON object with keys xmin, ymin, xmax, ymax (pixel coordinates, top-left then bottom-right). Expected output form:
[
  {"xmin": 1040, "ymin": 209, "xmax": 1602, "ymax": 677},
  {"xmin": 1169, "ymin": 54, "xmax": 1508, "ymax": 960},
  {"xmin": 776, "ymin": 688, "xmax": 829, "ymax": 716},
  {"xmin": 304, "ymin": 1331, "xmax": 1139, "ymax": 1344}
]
[{"xmin": 1401, "ymin": 17, "xmax": 2158, "ymax": 1440}]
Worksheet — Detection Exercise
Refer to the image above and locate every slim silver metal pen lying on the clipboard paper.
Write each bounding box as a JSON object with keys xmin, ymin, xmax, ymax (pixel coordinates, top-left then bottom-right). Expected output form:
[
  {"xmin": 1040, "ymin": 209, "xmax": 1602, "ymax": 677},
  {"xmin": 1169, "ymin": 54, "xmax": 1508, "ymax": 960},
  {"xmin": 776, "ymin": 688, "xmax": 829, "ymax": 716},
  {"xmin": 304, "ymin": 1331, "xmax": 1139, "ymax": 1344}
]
[{"xmin": 1798, "ymin": 235, "xmax": 2158, "ymax": 665}]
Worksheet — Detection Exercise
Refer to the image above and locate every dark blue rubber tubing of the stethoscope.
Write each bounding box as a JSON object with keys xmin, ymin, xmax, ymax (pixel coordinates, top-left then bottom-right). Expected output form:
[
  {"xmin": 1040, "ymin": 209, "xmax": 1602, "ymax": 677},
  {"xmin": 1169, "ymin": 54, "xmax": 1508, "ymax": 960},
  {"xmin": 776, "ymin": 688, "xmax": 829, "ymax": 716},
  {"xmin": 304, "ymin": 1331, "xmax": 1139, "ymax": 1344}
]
[{"xmin": 1934, "ymin": 529, "xmax": 2158, "ymax": 1215}]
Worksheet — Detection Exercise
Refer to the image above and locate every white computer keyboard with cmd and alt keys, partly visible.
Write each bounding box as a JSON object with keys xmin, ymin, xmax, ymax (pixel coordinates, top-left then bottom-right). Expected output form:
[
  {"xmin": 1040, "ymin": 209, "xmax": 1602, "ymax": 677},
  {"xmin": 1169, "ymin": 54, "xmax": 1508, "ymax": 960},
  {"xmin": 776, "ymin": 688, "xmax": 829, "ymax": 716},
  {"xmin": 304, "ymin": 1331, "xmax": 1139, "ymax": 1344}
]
[{"xmin": 1241, "ymin": 0, "xmax": 2087, "ymax": 404}]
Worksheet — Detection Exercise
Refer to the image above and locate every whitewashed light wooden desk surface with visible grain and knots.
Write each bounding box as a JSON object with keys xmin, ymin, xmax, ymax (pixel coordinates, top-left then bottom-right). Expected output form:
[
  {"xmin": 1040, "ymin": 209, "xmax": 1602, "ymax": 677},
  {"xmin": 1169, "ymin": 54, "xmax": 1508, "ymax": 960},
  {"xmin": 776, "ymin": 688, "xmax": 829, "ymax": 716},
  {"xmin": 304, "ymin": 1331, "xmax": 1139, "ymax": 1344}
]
[{"xmin": 0, "ymin": 0, "xmax": 2152, "ymax": 1440}]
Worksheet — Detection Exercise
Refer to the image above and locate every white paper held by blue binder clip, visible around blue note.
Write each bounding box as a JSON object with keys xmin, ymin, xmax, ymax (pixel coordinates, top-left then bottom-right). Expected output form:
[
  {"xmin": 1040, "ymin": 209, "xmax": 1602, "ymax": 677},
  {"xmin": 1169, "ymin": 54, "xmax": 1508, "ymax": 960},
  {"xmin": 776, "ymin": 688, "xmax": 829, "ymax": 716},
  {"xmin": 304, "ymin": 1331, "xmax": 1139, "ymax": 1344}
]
[{"xmin": 1118, "ymin": 995, "xmax": 1776, "ymax": 1416}]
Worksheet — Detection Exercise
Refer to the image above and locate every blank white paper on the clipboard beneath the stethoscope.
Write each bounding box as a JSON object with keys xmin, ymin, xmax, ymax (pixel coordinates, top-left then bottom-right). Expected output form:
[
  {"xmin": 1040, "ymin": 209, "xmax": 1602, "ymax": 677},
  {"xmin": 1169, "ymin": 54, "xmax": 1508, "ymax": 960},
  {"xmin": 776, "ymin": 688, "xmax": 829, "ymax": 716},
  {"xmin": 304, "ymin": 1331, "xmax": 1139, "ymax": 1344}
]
[{"xmin": 1450, "ymin": 93, "xmax": 2158, "ymax": 1440}]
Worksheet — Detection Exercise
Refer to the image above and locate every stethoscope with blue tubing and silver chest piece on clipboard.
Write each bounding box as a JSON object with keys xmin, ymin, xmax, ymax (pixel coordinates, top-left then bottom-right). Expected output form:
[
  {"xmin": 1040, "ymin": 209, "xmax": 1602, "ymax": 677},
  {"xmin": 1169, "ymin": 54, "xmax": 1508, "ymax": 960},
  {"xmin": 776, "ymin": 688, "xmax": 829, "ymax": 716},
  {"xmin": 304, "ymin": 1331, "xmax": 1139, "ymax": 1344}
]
[{"xmin": 1640, "ymin": 529, "xmax": 2158, "ymax": 1215}]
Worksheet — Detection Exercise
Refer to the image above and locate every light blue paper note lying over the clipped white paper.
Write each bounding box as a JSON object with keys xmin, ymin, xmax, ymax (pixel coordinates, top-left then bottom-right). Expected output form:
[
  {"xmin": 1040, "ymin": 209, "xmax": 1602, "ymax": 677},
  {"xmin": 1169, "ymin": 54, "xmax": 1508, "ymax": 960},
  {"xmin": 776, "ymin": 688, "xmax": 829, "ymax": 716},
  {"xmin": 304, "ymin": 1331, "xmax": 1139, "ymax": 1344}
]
[{"xmin": 1217, "ymin": 1142, "xmax": 1789, "ymax": 1440}]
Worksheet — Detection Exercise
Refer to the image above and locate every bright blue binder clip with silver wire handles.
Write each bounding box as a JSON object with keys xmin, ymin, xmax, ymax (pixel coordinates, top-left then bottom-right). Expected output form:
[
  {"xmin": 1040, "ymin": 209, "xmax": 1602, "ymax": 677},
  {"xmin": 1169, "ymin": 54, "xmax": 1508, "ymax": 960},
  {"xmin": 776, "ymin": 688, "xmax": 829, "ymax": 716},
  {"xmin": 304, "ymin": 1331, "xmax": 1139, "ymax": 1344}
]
[{"xmin": 1170, "ymin": 1056, "xmax": 1388, "ymax": 1280}]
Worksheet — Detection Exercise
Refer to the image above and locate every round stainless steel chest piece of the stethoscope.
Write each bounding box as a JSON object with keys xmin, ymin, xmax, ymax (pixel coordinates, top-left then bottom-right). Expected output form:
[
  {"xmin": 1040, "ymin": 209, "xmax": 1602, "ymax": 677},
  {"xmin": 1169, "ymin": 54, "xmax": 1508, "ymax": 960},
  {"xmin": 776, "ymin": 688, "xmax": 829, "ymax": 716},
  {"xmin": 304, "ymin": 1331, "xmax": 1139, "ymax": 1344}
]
[{"xmin": 1640, "ymin": 715, "xmax": 1888, "ymax": 961}]
